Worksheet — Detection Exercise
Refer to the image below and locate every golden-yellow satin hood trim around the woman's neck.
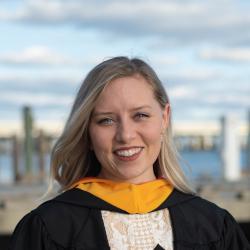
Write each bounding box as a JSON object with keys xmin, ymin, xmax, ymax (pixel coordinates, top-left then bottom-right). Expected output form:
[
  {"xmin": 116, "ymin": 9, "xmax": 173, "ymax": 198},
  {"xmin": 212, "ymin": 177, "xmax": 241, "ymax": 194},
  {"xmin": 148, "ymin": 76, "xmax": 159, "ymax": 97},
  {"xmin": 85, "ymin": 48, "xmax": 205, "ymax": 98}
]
[{"xmin": 73, "ymin": 177, "xmax": 173, "ymax": 214}]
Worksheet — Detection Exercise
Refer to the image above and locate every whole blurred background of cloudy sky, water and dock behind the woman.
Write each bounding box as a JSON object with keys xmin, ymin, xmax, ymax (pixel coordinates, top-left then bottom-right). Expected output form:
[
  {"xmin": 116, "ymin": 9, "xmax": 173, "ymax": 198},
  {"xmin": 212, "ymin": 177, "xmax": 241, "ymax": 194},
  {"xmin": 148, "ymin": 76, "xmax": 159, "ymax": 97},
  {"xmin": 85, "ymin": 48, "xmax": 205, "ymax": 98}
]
[{"xmin": 0, "ymin": 0, "xmax": 250, "ymax": 246}]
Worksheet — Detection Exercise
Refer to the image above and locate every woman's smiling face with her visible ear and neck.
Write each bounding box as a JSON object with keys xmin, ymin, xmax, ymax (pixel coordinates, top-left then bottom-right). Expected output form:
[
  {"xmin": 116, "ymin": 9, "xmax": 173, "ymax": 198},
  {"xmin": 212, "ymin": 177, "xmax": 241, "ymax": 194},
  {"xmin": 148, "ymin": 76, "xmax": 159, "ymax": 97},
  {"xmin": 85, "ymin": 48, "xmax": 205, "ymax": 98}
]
[{"xmin": 89, "ymin": 75, "xmax": 169, "ymax": 184}]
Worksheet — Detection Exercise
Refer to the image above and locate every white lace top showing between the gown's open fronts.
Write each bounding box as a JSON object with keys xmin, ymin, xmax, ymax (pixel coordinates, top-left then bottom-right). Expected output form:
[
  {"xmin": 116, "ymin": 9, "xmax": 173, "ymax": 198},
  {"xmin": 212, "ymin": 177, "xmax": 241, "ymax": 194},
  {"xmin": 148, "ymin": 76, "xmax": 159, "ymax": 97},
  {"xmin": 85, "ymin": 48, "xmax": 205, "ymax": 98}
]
[{"xmin": 102, "ymin": 208, "xmax": 173, "ymax": 250}]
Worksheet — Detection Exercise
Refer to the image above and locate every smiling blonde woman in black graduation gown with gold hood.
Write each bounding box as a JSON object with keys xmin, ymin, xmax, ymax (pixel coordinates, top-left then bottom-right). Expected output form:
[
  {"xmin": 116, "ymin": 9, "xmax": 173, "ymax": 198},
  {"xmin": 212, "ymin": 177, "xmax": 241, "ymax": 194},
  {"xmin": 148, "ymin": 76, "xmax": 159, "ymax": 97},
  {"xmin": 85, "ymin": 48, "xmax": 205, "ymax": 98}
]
[{"xmin": 10, "ymin": 57, "xmax": 250, "ymax": 250}]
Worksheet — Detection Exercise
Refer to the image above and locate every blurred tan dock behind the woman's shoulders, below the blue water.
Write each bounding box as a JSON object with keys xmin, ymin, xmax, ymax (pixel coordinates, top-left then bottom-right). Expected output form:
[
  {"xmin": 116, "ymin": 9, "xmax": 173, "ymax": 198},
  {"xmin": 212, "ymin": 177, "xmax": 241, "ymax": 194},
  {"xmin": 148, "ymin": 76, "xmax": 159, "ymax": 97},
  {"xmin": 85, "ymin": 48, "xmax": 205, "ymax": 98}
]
[{"xmin": 0, "ymin": 179, "xmax": 250, "ymax": 249}]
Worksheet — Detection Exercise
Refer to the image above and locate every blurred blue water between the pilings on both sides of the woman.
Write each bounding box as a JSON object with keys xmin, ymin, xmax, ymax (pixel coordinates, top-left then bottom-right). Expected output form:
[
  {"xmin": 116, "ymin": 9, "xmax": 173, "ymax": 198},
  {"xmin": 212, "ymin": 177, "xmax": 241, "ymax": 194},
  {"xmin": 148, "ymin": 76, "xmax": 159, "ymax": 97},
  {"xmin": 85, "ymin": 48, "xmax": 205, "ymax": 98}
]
[{"xmin": 0, "ymin": 150, "xmax": 247, "ymax": 183}]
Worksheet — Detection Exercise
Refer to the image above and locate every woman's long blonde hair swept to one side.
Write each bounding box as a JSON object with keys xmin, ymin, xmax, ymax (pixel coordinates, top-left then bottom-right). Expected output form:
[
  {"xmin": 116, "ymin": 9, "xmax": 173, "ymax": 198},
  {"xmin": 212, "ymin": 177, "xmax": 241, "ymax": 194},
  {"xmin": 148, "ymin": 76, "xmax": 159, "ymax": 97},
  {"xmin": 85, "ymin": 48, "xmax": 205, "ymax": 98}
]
[{"xmin": 48, "ymin": 57, "xmax": 193, "ymax": 193}]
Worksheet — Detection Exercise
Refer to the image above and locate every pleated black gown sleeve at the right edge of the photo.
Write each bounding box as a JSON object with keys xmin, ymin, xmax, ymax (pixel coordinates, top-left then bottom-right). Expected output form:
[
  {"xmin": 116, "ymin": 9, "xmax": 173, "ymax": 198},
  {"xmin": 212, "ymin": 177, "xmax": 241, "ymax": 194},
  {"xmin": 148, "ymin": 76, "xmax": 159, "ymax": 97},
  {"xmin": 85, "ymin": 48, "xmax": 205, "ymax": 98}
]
[{"xmin": 218, "ymin": 212, "xmax": 250, "ymax": 250}]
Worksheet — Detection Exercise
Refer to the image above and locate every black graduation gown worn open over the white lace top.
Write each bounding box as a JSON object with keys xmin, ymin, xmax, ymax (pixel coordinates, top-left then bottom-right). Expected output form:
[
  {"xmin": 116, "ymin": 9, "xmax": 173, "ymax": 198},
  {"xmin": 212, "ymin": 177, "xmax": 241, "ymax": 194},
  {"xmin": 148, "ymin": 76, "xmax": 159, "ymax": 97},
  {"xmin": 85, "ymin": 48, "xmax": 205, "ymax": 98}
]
[{"xmin": 9, "ymin": 188, "xmax": 250, "ymax": 250}]
